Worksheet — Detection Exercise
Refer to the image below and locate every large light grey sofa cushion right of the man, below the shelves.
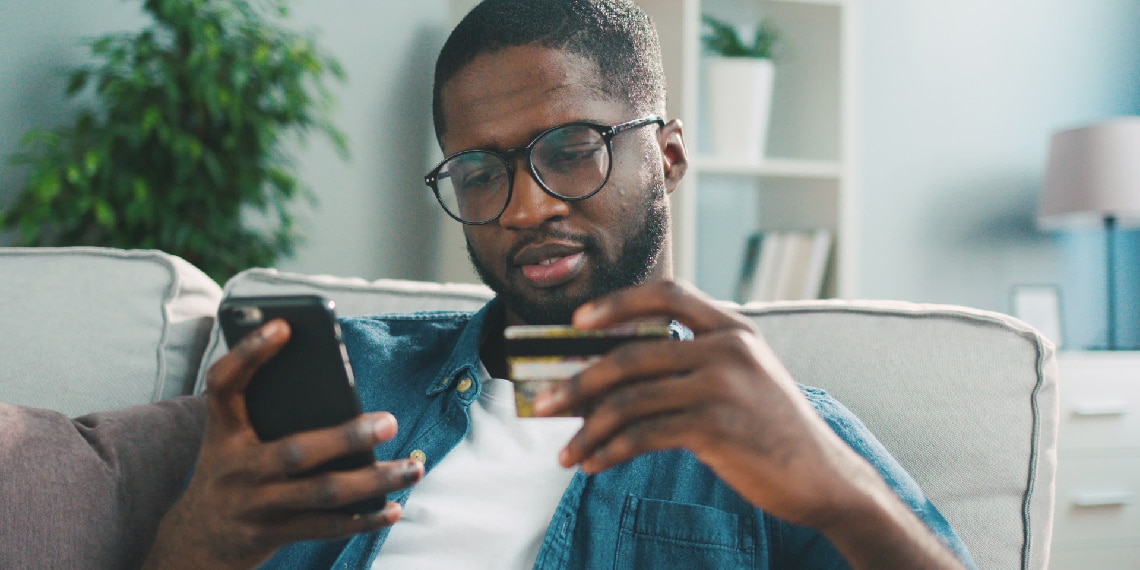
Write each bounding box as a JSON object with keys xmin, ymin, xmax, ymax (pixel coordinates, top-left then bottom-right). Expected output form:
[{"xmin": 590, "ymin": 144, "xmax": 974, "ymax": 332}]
[{"xmin": 742, "ymin": 301, "xmax": 1058, "ymax": 569}]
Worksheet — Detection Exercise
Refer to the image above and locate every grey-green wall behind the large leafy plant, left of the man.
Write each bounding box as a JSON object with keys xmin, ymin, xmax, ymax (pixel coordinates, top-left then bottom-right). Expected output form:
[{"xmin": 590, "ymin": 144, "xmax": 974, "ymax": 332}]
[{"xmin": 0, "ymin": 0, "xmax": 449, "ymax": 278}]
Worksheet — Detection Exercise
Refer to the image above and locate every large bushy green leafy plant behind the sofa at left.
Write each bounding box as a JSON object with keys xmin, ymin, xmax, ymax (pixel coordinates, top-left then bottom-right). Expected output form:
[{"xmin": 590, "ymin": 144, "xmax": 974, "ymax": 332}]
[{"xmin": 0, "ymin": 0, "xmax": 347, "ymax": 283}]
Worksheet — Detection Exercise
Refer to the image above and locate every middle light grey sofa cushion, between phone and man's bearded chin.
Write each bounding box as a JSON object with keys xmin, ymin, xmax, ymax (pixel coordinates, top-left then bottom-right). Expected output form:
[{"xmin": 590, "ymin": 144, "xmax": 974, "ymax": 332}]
[{"xmin": 194, "ymin": 269, "xmax": 492, "ymax": 393}]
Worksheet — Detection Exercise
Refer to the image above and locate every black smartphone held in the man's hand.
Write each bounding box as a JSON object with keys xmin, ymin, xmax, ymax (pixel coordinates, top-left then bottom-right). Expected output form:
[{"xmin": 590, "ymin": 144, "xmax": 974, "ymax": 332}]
[{"xmin": 218, "ymin": 295, "xmax": 388, "ymax": 513}]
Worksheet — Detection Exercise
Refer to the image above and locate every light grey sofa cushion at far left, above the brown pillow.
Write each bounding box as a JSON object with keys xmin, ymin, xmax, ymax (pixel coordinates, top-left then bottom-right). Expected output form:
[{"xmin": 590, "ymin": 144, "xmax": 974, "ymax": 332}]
[{"xmin": 0, "ymin": 247, "xmax": 221, "ymax": 416}]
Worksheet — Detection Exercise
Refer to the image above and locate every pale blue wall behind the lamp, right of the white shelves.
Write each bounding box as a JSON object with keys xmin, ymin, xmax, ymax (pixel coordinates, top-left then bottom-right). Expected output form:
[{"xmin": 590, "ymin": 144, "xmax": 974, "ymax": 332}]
[{"xmin": 858, "ymin": 0, "xmax": 1140, "ymax": 347}]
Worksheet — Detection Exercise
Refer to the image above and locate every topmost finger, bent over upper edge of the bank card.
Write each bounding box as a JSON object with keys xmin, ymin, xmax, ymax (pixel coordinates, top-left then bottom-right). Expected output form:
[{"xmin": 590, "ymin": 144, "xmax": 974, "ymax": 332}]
[{"xmin": 573, "ymin": 279, "xmax": 752, "ymax": 334}]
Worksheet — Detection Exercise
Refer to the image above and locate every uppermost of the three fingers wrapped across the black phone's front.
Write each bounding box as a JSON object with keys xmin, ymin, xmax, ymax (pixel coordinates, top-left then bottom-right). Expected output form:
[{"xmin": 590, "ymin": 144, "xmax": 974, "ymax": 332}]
[{"xmin": 251, "ymin": 412, "xmax": 399, "ymax": 479}]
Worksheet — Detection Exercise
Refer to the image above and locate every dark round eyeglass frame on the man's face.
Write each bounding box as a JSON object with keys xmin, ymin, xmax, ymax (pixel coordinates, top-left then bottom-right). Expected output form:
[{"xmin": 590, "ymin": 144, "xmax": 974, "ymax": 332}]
[{"xmin": 424, "ymin": 115, "xmax": 665, "ymax": 226}]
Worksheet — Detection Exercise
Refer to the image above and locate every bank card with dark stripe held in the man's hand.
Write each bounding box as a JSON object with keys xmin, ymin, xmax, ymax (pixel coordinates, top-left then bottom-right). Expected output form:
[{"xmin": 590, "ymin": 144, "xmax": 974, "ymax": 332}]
[{"xmin": 503, "ymin": 323, "xmax": 670, "ymax": 417}]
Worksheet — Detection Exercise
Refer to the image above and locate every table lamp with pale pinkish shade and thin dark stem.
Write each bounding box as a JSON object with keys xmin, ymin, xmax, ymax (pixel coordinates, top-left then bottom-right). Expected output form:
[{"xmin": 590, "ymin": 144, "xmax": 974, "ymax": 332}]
[{"xmin": 1037, "ymin": 116, "xmax": 1140, "ymax": 350}]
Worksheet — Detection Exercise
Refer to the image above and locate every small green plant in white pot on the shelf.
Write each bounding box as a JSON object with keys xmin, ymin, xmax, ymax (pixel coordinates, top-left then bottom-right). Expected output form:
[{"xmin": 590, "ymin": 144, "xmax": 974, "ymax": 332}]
[{"xmin": 701, "ymin": 15, "xmax": 780, "ymax": 161}]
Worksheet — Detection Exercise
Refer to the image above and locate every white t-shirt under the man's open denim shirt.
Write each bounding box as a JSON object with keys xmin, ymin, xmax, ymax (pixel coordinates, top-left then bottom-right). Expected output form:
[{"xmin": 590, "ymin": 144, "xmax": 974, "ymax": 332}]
[{"xmin": 373, "ymin": 368, "xmax": 581, "ymax": 569}]
